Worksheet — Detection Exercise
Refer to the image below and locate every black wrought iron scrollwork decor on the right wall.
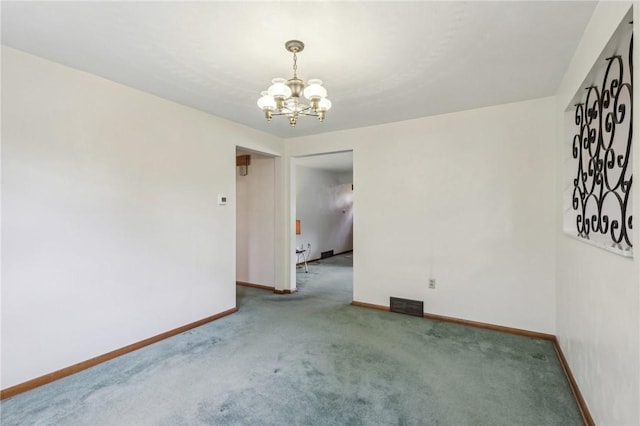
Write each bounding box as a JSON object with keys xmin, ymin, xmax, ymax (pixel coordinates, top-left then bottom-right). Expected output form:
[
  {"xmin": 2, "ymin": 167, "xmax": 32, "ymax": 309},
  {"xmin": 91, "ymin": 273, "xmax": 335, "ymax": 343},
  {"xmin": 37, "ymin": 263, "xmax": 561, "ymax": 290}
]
[{"xmin": 571, "ymin": 28, "xmax": 633, "ymax": 252}]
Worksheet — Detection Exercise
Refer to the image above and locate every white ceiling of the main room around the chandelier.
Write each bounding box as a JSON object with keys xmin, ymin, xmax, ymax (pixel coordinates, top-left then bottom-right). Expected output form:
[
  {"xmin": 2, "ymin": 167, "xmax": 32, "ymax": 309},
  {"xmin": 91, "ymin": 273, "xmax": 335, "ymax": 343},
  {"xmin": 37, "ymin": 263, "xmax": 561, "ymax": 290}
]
[{"xmin": 1, "ymin": 1, "xmax": 595, "ymax": 138}]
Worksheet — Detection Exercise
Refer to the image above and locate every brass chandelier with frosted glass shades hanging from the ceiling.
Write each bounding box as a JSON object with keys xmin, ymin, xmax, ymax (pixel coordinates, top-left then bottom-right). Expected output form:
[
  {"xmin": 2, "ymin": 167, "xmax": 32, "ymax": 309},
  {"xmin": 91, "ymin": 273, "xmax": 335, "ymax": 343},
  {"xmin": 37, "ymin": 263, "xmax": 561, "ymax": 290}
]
[{"xmin": 258, "ymin": 40, "xmax": 331, "ymax": 127}]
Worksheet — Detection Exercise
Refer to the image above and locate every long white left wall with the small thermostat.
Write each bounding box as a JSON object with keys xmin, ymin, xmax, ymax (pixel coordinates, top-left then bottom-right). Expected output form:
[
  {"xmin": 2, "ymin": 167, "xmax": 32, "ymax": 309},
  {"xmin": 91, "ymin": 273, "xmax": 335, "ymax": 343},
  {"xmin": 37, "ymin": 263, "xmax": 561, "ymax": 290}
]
[{"xmin": 2, "ymin": 47, "xmax": 283, "ymax": 388}]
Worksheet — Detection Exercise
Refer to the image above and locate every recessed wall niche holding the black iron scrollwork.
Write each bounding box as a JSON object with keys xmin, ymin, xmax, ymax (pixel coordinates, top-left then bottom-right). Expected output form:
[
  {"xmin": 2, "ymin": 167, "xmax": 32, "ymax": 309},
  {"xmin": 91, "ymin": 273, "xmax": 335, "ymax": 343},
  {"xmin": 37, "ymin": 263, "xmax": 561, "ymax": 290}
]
[{"xmin": 563, "ymin": 11, "xmax": 633, "ymax": 257}]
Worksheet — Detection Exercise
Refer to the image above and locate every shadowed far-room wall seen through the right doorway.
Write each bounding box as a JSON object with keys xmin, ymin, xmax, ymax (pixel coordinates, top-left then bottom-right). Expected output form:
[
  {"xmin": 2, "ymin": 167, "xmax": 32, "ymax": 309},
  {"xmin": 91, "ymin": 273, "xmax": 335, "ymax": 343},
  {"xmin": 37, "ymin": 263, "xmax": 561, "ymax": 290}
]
[{"xmin": 296, "ymin": 166, "xmax": 353, "ymax": 259}]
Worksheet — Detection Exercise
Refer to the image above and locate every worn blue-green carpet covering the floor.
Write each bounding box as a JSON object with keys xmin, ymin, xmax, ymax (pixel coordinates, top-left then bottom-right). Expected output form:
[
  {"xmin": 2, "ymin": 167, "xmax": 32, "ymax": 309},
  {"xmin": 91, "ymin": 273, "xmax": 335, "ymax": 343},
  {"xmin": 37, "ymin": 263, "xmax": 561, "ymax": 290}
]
[{"xmin": 0, "ymin": 256, "xmax": 582, "ymax": 426}]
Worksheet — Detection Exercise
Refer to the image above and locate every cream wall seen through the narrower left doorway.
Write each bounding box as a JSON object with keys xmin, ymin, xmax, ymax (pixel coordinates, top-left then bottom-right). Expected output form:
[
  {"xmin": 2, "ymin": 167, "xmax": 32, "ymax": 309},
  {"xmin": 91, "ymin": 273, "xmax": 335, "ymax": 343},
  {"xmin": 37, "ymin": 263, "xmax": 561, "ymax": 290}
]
[{"xmin": 236, "ymin": 154, "xmax": 276, "ymax": 287}]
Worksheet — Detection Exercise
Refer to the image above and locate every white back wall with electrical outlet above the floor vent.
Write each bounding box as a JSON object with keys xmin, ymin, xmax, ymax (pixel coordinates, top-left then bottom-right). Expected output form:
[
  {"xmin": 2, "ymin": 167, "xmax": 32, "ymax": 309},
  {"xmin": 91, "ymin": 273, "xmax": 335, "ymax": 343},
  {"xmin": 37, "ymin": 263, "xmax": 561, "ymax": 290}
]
[{"xmin": 287, "ymin": 98, "xmax": 556, "ymax": 333}]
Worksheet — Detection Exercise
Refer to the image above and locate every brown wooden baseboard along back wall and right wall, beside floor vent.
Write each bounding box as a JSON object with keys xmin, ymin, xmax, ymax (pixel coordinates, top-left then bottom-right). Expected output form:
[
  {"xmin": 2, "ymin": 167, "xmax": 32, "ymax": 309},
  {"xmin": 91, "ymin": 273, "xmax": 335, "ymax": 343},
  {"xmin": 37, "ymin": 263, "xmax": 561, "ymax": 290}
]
[{"xmin": 351, "ymin": 300, "xmax": 595, "ymax": 426}]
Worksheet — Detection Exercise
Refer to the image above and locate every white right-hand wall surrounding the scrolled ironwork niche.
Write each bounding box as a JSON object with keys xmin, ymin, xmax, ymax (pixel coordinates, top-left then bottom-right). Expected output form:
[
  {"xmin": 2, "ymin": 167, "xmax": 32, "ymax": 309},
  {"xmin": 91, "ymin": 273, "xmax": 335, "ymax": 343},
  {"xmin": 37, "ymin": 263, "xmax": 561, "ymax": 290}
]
[{"xmin": 556, "ymin": 2, "xmax": 640, "ymax": 425}]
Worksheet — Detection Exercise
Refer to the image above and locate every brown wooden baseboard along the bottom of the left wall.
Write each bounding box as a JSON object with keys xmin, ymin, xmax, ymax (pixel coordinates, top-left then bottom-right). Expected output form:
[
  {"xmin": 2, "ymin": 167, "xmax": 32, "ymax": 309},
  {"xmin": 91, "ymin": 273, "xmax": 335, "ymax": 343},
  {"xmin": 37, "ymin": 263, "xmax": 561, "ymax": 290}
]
[{"xmin": 0, "ymin": 308, "xmax": 238, "ymax": 400}]
